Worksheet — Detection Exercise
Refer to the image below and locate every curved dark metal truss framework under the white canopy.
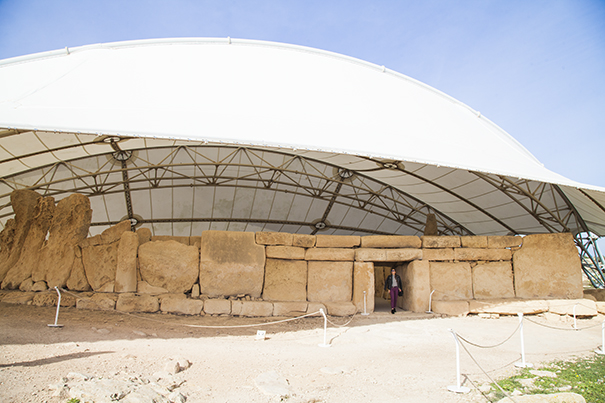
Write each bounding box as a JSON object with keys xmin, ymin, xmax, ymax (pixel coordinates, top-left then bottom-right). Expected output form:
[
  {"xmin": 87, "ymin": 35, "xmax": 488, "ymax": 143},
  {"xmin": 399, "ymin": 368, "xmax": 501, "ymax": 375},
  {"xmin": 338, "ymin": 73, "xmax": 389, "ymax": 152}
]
[{"xmin": 0, "ymin": 139, "xmax": 605, "ymax": 278}]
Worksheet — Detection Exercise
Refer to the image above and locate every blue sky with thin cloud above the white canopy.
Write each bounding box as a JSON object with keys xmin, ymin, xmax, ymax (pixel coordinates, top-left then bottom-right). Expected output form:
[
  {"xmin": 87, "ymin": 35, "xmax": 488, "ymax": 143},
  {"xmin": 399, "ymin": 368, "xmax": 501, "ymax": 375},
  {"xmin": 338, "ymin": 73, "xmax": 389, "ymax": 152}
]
[{"xmin": 0, "ymin": 0, "xmax": 605, "ymax": 187}]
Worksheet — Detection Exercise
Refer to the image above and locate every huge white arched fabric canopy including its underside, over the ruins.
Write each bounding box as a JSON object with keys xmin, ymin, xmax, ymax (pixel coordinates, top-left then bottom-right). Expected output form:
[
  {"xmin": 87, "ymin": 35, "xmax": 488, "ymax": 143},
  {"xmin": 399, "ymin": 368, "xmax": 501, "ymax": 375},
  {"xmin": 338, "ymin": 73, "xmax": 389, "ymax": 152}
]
[{"xmin": 0, "ymin": 38, "xmax": 605, "ymax": 235}]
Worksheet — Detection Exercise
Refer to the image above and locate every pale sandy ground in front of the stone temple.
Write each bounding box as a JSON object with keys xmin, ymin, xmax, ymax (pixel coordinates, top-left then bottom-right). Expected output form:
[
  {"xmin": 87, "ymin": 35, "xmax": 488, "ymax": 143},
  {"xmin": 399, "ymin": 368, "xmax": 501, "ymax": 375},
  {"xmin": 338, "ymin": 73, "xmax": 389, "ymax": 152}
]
[{"xmin": 0, "ymin": 303, "xmax": 604, "ymax": 403}]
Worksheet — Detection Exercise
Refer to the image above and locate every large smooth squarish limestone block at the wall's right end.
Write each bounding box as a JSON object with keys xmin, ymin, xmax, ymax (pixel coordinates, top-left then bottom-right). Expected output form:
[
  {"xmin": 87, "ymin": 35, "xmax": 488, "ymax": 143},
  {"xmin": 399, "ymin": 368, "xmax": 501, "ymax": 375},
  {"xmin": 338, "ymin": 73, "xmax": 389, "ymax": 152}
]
[{"xmin": 513, "ymin": 233, "xmax": 583, "ymax": 298}]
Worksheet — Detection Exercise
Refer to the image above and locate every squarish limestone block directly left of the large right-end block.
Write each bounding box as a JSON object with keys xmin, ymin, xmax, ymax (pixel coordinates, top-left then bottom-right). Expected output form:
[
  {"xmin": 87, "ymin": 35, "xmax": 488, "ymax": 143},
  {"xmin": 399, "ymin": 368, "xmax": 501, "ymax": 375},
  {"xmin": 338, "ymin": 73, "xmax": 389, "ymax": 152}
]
[{"xmin": 473, "ymin": 262, "xmax": 515, "ymax": 299}]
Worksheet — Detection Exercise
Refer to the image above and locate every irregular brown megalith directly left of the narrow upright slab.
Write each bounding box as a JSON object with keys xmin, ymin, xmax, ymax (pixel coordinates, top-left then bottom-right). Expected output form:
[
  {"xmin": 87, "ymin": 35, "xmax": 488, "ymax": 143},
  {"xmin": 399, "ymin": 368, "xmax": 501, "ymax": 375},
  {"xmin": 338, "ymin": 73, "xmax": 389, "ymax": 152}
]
[{"xmin": 80, "ymin": 220, "xmax": 131, "ymax": 292}]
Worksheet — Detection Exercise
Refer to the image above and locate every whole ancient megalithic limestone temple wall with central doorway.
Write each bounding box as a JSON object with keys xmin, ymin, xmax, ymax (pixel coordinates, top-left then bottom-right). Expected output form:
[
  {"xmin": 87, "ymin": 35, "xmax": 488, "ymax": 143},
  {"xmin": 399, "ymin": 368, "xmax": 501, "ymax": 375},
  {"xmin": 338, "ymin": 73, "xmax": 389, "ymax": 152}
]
[{"xmin": 0, "ymin": 191, "xmax": 582, "ymax": 316}]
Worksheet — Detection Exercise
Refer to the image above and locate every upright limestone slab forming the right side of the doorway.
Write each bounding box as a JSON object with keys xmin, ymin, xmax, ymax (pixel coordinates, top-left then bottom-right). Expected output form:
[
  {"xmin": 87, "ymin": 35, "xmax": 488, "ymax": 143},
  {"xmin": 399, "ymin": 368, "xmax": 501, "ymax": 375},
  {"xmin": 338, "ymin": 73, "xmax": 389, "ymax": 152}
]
[{"xmin": 401, "ymin": 260, "xmax": 431, "ymax": 312}]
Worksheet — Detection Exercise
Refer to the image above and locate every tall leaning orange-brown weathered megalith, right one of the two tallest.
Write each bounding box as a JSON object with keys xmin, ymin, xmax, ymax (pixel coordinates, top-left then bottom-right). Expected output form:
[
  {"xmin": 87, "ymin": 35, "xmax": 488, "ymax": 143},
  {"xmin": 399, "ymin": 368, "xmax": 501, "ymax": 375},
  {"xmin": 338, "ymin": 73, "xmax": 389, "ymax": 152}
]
[{"xmin": 32, "ymin": 193, "xmax": 92, "ymax": 288}]
